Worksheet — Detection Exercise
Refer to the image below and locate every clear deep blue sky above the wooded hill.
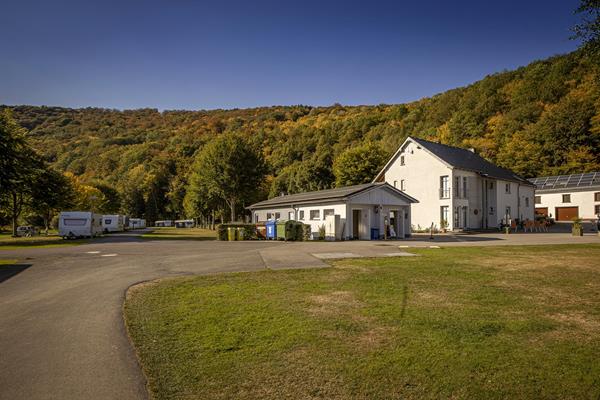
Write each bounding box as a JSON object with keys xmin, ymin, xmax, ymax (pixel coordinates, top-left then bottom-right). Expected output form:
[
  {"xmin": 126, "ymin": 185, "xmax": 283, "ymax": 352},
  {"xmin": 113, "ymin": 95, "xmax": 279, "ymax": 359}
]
[{"xmin": 0, "ymin": 0, "xmax": 579, "ymax": 109}]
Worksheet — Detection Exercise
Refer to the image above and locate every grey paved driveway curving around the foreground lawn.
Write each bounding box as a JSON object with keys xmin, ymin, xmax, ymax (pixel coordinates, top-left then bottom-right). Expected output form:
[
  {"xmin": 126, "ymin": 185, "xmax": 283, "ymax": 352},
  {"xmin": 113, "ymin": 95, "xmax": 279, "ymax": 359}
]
[{"xmin": 0, "ymin": 230, "xmax": 600, "ymax": 400}]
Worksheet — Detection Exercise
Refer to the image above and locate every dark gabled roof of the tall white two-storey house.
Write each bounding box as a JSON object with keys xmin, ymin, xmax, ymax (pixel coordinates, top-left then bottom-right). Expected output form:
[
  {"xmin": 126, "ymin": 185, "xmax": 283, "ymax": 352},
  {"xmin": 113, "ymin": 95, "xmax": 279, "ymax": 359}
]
[{"xmin": 375, "ymin": 136, "xmax": 531, "ymax": 185}]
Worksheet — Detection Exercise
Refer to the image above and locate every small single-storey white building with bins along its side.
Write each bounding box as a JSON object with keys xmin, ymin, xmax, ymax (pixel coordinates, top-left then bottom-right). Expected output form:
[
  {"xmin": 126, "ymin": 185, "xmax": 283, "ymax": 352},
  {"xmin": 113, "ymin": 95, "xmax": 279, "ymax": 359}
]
[{"xmin": 248, "ymin": 183, "xmax": 417, "ymax": 240}]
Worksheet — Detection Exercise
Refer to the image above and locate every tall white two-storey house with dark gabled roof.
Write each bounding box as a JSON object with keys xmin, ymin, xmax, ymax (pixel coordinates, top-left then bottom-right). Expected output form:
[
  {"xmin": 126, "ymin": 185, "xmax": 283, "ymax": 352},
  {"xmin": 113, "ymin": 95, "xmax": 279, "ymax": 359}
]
[{"xmin": 374, "ymin": 137, "xmax": 534, "ymax": 230}]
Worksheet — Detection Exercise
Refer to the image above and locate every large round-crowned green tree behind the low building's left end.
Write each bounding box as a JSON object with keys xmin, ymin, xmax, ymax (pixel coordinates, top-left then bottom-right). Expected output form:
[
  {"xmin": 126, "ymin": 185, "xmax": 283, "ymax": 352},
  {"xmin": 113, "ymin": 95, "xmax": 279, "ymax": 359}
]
[{"xmin": 191, "ymin": 134, "xmax": 265, "ymax": 221}]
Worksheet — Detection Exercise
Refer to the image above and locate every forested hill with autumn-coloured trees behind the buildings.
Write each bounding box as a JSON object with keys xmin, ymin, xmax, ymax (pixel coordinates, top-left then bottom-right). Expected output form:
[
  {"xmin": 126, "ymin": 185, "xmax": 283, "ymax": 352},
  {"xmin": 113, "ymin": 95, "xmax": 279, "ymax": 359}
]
[{"xmin": 4, "ymin": 52, "xmax": 600, "ymax": 216}]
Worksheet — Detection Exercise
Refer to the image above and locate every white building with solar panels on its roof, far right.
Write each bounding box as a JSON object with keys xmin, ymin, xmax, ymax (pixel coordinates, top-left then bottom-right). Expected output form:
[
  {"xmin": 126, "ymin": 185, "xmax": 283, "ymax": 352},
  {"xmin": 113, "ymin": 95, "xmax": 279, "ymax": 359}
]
[{"xmin": 531, "ymin": 172, "xmax": 600, "ymax": 221}]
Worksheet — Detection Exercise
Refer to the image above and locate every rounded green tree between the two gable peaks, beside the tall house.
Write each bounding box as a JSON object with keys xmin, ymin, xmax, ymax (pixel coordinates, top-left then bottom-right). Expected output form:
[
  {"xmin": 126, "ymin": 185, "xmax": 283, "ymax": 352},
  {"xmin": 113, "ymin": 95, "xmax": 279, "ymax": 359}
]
[{"xmin": 333, "ymin": 142, "xmax": 387, "ymax": 187}]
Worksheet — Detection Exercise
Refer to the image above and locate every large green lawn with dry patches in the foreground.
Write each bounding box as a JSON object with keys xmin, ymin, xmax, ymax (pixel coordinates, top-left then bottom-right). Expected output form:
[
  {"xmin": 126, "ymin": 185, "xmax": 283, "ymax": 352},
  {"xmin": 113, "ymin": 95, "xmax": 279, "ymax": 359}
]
[{"xmin": 124, "ymin": 245, "xmax": 600, "ymax": 399}]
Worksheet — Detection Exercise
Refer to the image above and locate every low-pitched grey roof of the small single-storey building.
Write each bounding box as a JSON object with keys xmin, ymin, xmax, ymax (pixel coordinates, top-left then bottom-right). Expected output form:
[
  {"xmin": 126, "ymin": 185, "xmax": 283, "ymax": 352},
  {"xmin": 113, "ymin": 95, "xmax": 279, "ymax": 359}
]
[{"xmin": 248, "ymin": 182, "xmax": 418, "ymax": 209}]
